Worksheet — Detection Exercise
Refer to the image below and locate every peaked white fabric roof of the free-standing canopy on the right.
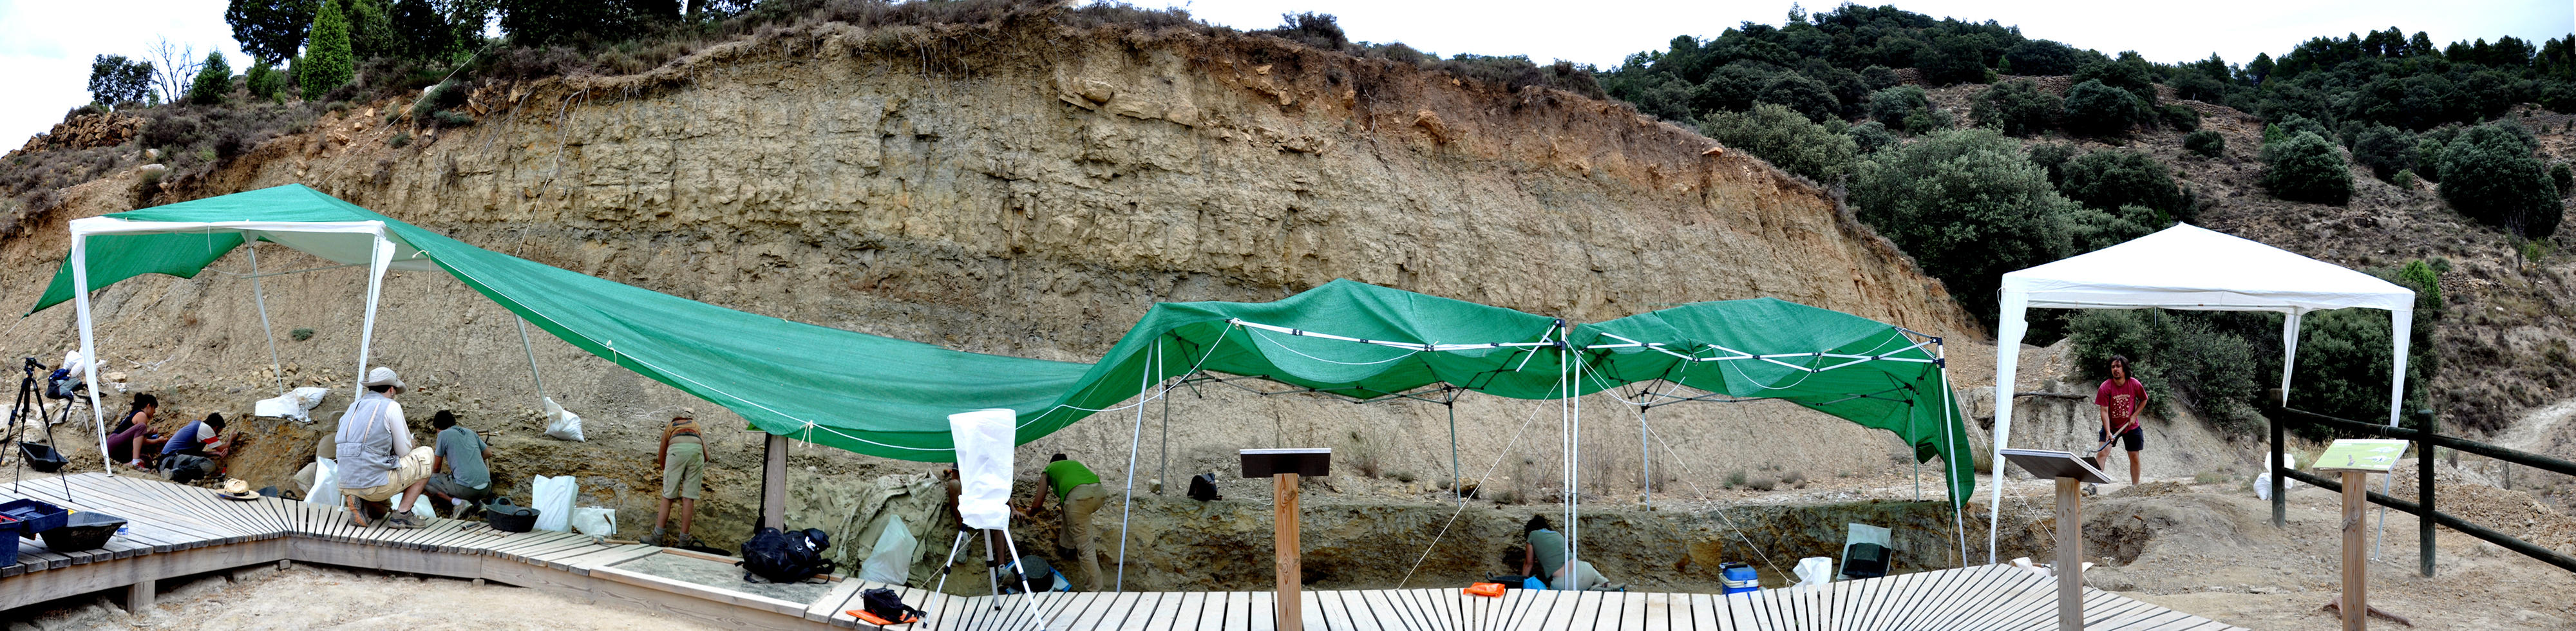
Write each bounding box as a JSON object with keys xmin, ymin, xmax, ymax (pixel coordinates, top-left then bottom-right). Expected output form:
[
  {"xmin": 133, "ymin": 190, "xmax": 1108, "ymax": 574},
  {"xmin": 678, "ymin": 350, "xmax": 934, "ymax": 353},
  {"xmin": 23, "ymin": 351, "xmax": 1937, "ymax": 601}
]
[{"xmin": 2004, "ymin": 224, "xmax": 2414, "ymax": 312}]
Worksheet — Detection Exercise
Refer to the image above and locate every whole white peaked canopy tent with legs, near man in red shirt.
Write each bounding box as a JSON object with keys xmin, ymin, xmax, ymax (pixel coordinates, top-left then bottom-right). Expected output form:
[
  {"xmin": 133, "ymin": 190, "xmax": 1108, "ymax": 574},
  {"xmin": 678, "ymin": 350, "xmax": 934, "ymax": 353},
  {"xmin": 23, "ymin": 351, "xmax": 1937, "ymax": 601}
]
[{"xmin": 1986, "ymin": 224, "xmax": 2414, "ymax": 561}]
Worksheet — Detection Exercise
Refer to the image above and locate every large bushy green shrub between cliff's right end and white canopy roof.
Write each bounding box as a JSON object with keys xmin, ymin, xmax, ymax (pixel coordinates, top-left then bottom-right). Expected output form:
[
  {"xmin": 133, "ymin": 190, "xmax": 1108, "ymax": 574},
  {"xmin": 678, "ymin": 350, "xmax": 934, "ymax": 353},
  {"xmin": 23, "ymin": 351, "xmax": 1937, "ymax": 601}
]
[{"xmin": 1850, "ymin": 129, "xmax": 2079, "ymax": 322}]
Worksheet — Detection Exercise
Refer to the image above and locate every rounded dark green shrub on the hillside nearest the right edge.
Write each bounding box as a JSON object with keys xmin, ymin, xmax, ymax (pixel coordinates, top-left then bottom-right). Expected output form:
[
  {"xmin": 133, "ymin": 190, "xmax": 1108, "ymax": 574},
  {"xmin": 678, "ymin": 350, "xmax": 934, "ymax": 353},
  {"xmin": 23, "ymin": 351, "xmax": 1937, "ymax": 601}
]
[{"xmin": 2442, "ymin": 121, "xmax": 2563, "ymax": 240}]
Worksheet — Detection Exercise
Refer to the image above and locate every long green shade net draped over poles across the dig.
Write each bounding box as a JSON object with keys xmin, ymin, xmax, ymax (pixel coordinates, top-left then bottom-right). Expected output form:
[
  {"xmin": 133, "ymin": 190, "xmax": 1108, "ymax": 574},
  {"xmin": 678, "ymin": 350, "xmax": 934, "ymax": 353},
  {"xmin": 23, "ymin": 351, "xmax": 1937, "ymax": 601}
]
[{"xmin": 28, "ymin": 185, "xmax": 1973, "ymax": 497}]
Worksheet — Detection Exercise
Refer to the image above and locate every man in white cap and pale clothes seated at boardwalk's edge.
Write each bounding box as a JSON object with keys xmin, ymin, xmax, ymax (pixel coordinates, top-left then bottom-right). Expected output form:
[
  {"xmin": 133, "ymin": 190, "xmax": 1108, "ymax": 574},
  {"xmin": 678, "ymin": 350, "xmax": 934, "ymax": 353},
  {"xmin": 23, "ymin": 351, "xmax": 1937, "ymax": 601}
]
[{"xmin": 335, "ymin": 366, "xmax": 435, "ymax": 528}]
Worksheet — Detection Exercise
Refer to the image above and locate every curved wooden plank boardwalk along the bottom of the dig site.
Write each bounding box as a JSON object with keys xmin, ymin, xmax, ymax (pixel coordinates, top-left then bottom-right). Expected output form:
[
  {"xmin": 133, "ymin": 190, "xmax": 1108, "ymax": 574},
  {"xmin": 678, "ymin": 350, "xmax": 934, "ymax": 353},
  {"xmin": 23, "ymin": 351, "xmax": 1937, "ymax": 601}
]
[{"xmin": 0, "ymin": 474, "xmax": 2236, "ymax": 631}]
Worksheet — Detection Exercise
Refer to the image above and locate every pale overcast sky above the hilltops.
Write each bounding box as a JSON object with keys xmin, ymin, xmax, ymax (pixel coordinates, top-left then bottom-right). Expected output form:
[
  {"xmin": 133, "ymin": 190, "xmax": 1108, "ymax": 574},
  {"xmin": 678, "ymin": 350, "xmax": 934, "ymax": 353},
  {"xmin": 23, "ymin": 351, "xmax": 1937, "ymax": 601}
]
[{"xmin": 0, "ymin": 0, "xmax": 2576, "ymax": 149}]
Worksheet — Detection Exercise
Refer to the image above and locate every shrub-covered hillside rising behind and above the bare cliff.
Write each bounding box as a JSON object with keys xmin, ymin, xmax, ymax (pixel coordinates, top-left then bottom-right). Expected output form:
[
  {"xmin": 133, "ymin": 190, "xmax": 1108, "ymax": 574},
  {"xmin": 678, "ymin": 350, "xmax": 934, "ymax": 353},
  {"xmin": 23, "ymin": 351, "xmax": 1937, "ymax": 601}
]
[{"xmin": 0, "ymin": 0, "xmax": 2576, "ymax": 438}]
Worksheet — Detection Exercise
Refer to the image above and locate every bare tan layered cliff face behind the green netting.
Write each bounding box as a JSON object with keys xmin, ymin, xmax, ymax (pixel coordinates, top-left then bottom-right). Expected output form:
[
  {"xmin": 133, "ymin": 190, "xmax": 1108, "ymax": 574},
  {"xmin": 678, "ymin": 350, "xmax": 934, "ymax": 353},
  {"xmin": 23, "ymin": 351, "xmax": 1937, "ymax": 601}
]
[{"xmin": 0, "ymin": 21, "xmax": 1984, "ymax": 595}]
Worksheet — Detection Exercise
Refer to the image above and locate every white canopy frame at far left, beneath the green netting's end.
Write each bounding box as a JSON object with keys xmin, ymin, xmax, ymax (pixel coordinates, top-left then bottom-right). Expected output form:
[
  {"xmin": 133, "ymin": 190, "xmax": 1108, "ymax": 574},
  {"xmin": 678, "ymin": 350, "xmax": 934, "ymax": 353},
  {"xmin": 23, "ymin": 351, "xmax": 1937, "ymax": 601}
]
[{"xmin": 67, "ymin": 216, "xmax": 438, "ymax": 469}]
